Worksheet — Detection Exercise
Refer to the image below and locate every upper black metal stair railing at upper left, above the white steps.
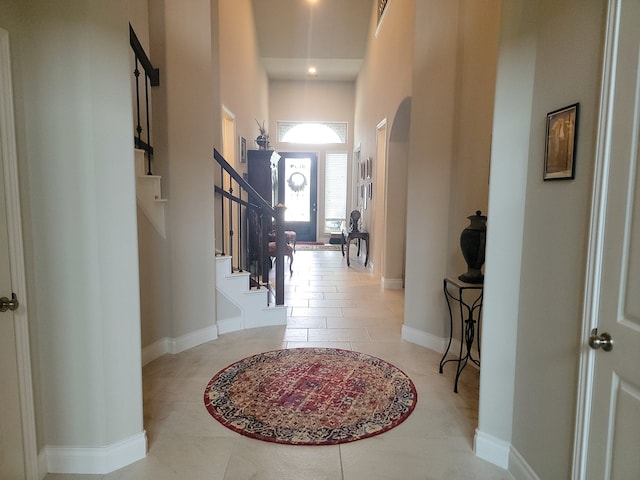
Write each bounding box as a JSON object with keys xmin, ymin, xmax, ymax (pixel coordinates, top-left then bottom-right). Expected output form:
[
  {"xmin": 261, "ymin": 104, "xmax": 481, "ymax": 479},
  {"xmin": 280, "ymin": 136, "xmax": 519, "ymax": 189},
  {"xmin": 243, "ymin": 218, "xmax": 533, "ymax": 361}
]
[{"xmin": 129, "ymin": 24, "xmax": 160, "ymax": 175}]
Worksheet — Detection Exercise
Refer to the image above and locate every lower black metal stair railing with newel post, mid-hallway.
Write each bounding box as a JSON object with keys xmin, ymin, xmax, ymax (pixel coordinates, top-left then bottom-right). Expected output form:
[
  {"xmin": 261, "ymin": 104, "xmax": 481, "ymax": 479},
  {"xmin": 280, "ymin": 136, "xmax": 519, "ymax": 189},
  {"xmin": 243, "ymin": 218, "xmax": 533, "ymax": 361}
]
[{"xmin": 213, "ymin": 149, "xmax": 286, "ymax": 305}]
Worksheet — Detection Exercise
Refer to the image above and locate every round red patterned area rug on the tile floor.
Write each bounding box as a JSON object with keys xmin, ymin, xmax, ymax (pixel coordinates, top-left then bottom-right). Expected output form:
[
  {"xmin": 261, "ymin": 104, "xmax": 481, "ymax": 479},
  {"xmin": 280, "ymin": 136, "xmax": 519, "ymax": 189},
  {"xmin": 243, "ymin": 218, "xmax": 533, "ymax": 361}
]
[{"xmin": 204, "ymin": 348, "xmax": 417, "ymax": 445}]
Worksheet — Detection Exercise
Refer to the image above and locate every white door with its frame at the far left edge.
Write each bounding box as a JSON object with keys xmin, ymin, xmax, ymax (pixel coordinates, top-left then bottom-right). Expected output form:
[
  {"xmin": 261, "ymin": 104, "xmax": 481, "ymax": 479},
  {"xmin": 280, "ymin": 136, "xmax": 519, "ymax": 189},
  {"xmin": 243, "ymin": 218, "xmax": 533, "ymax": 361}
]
[{"xmin": 0, "ymin": 29, "xmax": 38, "ymax": 479}]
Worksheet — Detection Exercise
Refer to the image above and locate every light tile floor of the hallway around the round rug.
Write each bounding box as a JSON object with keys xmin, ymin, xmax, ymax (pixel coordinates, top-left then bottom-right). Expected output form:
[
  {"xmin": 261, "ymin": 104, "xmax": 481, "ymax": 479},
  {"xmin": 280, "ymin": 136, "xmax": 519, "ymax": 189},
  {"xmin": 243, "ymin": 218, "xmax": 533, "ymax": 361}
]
[{"xmin": 46, "ymin": 247, "xmax": 513, "ymax": 480}]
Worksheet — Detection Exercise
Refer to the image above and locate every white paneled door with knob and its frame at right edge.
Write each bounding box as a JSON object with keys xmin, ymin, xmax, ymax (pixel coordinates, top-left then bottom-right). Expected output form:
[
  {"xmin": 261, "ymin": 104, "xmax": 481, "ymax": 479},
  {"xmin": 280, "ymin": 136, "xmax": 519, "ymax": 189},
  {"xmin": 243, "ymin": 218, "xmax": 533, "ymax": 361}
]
[{"xmin": 574, "ymin": 0, "xmax": 640, "ymax": 479}]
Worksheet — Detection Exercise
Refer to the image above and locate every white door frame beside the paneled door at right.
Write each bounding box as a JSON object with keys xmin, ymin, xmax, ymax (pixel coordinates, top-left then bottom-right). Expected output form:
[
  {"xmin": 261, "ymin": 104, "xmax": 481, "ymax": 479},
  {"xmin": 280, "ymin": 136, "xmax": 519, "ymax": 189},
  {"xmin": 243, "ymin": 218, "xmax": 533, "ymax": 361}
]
[{"xmin": 571, "ymin": 0, "xmax": 622, "ymax": 474}]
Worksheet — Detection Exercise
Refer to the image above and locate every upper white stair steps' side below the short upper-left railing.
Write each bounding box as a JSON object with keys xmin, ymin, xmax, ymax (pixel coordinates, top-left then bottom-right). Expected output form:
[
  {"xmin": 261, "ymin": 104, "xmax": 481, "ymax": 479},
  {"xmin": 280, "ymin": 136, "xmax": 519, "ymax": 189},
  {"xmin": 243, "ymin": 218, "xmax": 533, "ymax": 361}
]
[{"xmin": 135, "ymin": 148, "xmax": 167, "ymax": 239}]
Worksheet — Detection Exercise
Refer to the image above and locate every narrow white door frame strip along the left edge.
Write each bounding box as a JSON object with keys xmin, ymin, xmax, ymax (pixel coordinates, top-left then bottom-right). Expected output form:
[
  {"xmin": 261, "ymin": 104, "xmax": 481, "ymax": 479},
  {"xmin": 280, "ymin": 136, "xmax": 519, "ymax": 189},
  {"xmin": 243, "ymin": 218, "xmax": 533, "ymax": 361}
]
[{"xmin": 0, "ymin": 28, "xmax": 39, "ymax": 480}]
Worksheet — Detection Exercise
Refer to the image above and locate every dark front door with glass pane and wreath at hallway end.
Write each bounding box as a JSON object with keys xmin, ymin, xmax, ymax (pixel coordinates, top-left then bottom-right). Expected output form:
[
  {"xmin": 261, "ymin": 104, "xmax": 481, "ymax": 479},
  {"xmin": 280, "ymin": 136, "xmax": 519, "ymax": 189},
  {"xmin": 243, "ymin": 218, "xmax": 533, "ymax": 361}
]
[{"xmin": 278, "ymin": 152, "xmax": 318, "ymax": 242}]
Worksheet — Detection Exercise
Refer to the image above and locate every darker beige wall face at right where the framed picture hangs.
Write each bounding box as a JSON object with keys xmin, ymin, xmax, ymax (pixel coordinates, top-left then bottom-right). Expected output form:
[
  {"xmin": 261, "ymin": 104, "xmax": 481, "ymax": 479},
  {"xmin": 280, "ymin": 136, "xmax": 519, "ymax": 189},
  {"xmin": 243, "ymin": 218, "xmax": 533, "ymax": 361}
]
[{"xmin": 487, "ymin": 0, "xmax": 606, "ymax": 478}]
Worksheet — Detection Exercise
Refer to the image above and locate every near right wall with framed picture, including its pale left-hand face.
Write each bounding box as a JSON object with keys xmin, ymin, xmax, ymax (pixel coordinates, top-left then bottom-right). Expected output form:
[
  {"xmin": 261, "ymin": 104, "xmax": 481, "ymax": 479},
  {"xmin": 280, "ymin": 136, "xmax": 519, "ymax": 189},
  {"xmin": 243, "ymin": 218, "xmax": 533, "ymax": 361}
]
[{"xmin": 479, "ymin": 0, "xmax": 606, "ymax": 478}]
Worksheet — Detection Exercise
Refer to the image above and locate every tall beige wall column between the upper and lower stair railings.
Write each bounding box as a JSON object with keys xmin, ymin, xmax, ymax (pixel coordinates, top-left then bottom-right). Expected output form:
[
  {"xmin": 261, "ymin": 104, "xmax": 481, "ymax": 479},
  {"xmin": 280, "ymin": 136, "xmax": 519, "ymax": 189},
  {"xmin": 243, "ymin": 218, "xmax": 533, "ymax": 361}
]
[{"xmin": 145, "ymin": 0, "xmax": 220, "ymax": 346}]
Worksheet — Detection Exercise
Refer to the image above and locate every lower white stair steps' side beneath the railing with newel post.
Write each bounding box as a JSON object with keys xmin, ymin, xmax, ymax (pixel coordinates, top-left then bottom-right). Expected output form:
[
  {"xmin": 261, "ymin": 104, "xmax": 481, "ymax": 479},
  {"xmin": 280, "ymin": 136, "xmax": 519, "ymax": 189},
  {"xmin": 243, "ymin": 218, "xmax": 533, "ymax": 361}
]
[{"xmin": 216, "ymin": 256, "xmax": 287, "ymax": 334}]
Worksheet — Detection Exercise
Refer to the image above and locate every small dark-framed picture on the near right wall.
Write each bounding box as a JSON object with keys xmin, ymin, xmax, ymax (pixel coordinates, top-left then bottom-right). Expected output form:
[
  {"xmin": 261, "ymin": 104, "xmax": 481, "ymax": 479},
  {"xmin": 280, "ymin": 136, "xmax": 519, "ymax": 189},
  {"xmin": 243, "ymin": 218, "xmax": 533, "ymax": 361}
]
[{"xmin": 543, "ymin": 103, "xmax": 579, "ymax": 180}]
